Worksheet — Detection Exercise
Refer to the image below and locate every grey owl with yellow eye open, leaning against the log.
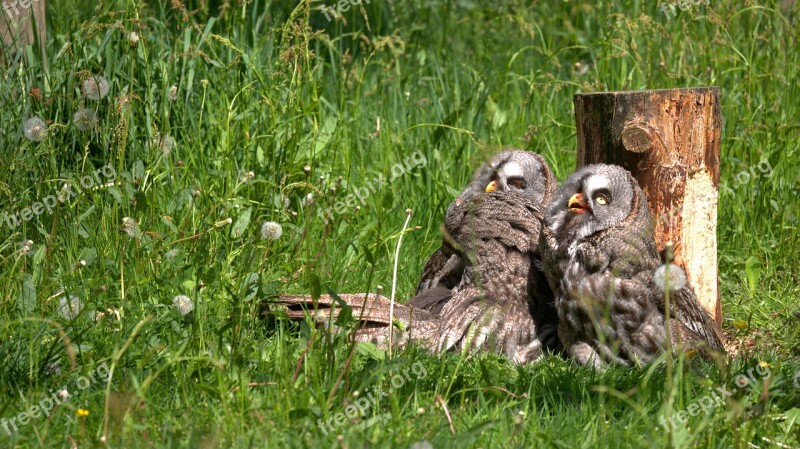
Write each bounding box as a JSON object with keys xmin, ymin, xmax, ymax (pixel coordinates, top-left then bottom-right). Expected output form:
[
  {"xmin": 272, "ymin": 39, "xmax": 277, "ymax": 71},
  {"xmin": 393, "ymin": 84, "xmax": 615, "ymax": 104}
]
[{"xmin": 539, "ymin": 164, "xmax": 723, "ymax": 367}]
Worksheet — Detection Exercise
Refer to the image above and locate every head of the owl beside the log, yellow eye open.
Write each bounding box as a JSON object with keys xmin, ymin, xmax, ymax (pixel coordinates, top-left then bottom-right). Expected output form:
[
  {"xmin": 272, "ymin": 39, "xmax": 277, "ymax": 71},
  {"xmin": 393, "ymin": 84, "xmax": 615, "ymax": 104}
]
[{"xmin": 544, "ymin": 164, "xmax": 650, "ymax": 241}]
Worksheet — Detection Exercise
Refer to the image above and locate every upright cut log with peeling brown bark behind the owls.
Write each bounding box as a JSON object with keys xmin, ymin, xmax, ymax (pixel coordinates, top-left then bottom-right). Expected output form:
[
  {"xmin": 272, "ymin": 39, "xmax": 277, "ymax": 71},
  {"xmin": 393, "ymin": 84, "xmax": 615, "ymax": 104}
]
[{"xmin": 574, "ymin": 87, "xmax": 722, "ymax": 326}]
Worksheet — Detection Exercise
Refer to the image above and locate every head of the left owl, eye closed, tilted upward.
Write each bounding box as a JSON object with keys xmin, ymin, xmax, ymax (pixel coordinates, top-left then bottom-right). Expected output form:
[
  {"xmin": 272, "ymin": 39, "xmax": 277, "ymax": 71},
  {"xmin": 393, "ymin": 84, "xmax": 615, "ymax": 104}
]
[{"xmin": 455, "ymin": 149, "xmax": 558, "ymax": 205}]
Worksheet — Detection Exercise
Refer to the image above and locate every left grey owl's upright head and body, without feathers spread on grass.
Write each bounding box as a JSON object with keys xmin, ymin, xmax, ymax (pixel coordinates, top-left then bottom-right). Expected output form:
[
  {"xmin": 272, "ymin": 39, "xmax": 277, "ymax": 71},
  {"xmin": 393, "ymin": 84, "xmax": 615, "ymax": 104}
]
[{"xmin": 409, "ymin": 150, "xmax": 558, "ymax": 364}]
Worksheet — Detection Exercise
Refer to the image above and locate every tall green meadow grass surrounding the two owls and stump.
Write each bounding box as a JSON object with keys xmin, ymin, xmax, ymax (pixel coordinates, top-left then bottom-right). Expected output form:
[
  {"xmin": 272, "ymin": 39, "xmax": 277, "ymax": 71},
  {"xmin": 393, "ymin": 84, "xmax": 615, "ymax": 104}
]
[{"xmin": 0, "ymin": 0, "xmax": 800, "ymax": 448}]
